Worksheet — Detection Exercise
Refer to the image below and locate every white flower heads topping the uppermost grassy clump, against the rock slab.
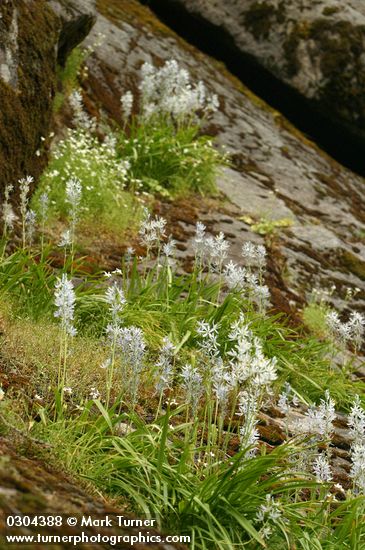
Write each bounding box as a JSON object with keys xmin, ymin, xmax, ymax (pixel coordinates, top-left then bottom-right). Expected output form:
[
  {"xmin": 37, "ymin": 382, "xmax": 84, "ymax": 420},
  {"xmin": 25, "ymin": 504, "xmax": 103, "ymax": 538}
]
[{"xmin": 129, "ymin": 60, "xmax": 219, "ymax": 122}]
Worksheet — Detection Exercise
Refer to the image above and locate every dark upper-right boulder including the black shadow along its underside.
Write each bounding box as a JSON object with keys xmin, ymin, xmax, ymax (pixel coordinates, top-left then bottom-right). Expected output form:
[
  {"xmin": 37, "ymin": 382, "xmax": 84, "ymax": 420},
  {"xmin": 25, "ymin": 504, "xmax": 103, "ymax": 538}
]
[{"xmin": 151, "ymin": 0, "xmax": 365, "ymax": 172}]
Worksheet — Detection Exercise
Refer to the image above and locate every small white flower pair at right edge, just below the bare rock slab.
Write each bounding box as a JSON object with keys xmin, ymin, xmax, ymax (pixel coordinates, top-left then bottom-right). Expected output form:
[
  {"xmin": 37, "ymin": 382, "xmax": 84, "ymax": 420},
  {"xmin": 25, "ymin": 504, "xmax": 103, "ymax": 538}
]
[{"xmin": 326, "ymin": 311, "xmax": 365, "ymax": 349}]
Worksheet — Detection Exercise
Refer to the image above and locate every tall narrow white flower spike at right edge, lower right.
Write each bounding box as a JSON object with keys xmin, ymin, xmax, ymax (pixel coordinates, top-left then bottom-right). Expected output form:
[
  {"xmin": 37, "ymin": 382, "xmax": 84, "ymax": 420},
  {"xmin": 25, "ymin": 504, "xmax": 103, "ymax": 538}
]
[{"xmin": 348, "ymin": 396, "xmax": 365, "ymax": 495}]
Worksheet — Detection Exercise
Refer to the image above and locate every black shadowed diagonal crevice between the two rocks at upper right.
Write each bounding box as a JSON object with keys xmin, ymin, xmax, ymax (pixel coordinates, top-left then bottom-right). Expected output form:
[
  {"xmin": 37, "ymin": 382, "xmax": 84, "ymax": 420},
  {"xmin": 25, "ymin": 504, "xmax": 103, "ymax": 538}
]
[{"xmin": 141, "ymin": 0, "xmax": 365, "ymax": 176}]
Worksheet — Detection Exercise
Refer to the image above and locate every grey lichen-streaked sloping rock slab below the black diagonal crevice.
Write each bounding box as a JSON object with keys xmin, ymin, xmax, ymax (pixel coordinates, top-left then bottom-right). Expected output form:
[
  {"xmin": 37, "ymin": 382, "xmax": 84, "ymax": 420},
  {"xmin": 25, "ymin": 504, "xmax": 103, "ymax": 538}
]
[{"xmin": 50, "ymin": 0, "xmax": 365, "ymax": 320}]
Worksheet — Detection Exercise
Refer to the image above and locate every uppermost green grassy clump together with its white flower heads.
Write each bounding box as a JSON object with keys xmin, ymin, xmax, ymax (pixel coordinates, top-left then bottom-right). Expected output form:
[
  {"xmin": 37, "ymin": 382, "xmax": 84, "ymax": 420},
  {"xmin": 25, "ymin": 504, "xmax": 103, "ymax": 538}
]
[{"xmin": 120, "ymin": 60, "xmax": 226, "ymax": 195}]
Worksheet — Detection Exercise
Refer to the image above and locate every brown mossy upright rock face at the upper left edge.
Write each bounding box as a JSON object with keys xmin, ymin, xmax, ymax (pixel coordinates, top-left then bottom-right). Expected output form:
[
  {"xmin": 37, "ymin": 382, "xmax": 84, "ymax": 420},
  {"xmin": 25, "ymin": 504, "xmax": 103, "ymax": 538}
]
[{"xmin": 0, "ymin": 0, "xmax": 59, "ymax": 198}]
